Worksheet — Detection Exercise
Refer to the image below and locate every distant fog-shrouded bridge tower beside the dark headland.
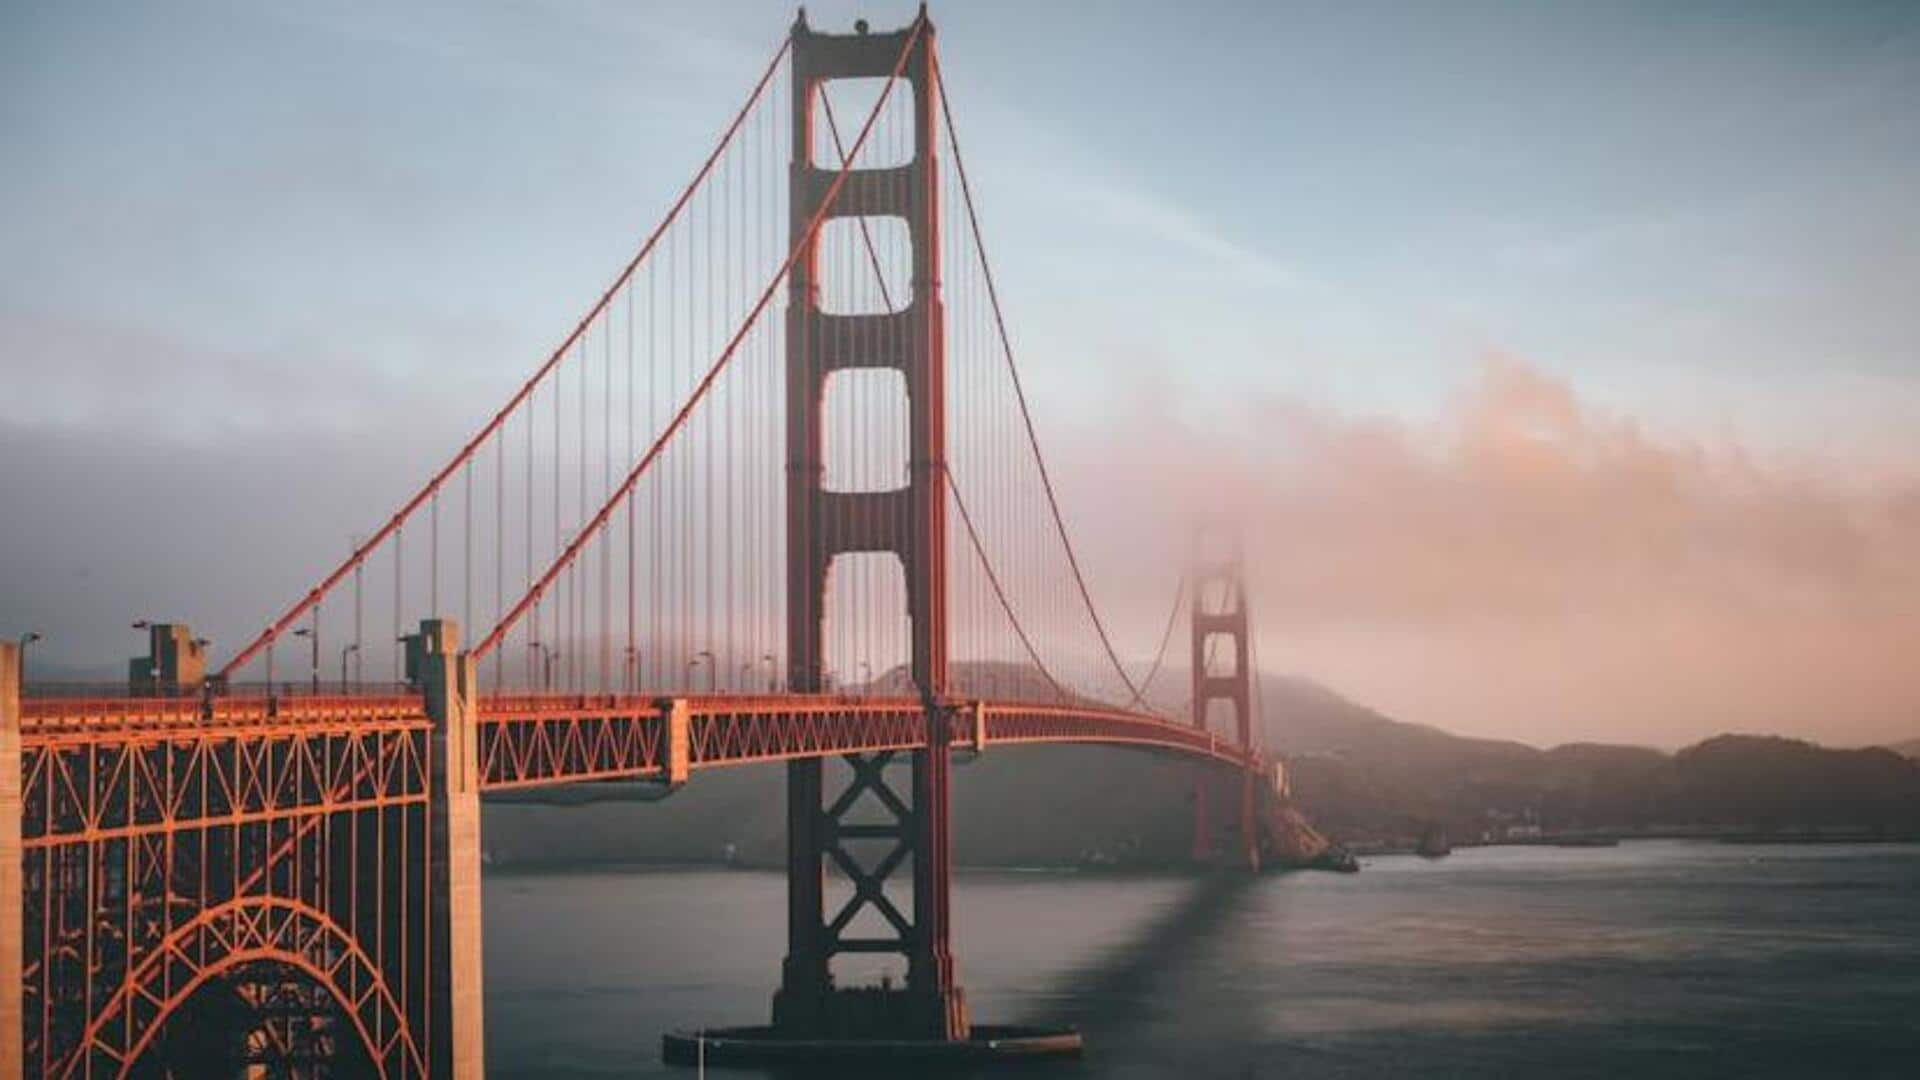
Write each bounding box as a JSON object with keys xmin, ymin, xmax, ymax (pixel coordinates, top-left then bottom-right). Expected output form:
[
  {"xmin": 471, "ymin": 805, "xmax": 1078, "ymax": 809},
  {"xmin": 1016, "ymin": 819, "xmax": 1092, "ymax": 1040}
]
[{"xmin": 1188, "ymin": 534, "xmax": 1260, "ymax": 871}]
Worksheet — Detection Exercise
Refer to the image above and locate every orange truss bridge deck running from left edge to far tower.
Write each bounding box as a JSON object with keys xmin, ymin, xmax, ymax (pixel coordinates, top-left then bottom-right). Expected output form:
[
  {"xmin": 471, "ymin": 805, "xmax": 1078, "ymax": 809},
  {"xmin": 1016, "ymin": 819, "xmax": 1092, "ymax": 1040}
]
[{"xmin": 21, "ymin": 694, "xmax": 1260, "ymax": 847}]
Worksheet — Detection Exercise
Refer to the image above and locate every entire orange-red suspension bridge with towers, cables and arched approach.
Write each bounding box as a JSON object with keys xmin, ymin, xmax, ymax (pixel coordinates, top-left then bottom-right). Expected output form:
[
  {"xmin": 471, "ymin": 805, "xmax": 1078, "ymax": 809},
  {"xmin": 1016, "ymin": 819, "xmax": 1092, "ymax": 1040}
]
[{"xmin": 0, "ymin": 12, "xmax": 1320, "ymax": 1076}]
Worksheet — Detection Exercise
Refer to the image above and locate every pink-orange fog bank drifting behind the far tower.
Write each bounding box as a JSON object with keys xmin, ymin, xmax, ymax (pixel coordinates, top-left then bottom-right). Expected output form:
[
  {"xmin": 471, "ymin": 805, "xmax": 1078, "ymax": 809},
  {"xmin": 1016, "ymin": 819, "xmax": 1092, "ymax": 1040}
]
[{"xmin": 1062, "ymin": 356, "xmax": 1920, "ymax": 746}]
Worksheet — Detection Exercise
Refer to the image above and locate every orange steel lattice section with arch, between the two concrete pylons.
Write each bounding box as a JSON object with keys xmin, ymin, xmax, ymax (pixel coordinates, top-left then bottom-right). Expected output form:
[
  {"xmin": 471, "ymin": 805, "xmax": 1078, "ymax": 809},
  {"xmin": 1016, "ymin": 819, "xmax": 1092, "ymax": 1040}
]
[{"xmin": 21, "ymin": 698, "xmax": 432, "ymax": 1076}]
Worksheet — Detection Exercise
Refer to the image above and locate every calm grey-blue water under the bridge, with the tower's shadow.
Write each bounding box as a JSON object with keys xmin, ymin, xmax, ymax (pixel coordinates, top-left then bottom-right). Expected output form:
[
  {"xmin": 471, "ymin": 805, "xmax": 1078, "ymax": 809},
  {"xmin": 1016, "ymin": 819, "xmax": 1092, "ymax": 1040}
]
[{"xmin": 486, "ymin": 842, "xmax": 1920, "ymax": 1078}]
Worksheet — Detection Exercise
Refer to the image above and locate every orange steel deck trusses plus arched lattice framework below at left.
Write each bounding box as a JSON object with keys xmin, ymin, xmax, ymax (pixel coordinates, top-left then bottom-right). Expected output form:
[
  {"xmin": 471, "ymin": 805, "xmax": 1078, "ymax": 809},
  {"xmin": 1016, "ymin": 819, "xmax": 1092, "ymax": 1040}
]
[{"xmin": 21, "ymin": 680, "xmax": 1260, "ymax": 1076}]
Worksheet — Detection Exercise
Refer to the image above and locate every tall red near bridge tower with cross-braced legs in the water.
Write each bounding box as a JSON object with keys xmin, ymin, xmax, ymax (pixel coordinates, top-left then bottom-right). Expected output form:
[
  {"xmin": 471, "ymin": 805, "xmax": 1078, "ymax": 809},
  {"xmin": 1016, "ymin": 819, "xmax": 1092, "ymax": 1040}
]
[{"xmin": 774, "ymin": 10, "xmax": 970, "ymax": 1040}]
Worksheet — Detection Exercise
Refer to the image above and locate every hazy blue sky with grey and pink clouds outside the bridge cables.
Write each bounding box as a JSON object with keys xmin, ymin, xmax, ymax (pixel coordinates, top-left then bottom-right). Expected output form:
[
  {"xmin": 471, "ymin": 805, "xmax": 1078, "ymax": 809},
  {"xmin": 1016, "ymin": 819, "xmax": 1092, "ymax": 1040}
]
[{"xmin": 0, "ymin": 0, "xmax": 1920, "ymax": 746}]
